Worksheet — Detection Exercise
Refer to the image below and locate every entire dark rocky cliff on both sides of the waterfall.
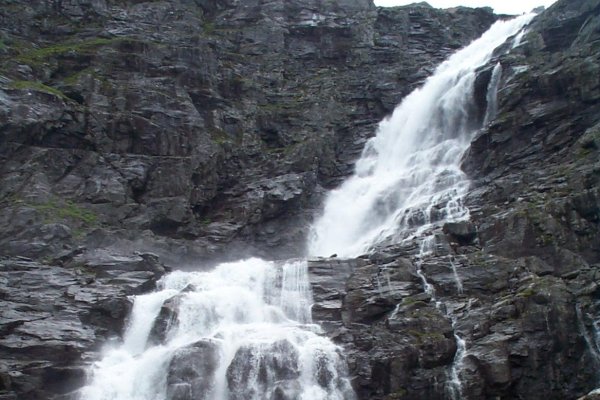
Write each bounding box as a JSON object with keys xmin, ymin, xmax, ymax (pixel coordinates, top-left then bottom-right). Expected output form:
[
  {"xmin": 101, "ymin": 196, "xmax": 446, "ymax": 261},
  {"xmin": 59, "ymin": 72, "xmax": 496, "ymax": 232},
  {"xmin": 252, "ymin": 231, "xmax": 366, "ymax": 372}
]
[{"xmin": 0, "ymin": 0, "xmax": 600, "ymax": 399}]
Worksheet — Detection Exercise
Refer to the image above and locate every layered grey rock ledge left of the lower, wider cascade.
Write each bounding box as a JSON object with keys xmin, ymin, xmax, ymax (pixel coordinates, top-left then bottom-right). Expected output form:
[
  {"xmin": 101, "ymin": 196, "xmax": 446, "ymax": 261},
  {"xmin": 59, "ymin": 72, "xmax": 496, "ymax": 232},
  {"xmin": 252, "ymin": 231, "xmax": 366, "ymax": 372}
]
[{"xmin": 0, "ymin": 254, "xmax": 165, "ymax": 400}]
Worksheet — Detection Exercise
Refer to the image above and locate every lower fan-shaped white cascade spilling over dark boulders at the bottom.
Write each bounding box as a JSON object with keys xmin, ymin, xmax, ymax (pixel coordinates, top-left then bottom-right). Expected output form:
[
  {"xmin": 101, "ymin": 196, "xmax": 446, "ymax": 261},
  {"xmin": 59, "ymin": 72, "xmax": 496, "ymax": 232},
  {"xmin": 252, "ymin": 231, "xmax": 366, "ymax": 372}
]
[{"xmin": 81, "ymin": 259, "xmax": 353, "ymax": 400}]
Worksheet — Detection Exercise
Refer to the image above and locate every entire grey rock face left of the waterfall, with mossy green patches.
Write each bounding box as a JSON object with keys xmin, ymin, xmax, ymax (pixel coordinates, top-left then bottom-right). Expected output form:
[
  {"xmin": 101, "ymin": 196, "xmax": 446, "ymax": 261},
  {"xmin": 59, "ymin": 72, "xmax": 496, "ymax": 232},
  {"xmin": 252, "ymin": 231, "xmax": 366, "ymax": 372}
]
[{"xmin": 0, "ymin": 0, "xmax": 496, "ymax": 400}]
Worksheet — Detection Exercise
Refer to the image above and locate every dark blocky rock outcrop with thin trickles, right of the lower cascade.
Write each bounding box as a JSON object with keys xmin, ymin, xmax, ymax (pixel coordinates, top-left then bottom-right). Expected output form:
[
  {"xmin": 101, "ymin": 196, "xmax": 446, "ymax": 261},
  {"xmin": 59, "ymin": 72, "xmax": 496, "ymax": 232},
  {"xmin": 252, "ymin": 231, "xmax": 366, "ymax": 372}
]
[{"xmin": 309, "ymin": 242, "xmax": 598, "ymax": 399}]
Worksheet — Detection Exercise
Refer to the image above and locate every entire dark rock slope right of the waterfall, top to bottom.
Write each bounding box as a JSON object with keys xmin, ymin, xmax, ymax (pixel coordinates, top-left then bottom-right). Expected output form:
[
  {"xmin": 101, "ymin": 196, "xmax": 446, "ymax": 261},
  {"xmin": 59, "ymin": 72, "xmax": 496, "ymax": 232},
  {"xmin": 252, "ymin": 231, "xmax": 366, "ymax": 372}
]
[{"xmin": 310, "ymin": 0, "xmax": 600, "ymax": 399}]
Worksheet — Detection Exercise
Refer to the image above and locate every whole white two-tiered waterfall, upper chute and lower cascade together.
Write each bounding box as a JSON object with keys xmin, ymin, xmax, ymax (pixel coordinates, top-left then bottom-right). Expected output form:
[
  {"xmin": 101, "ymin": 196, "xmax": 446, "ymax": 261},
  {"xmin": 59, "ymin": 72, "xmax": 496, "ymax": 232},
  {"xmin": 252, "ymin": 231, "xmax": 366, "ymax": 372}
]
[{"xmin": 81, "ymin": 16, "xmax": 531, "ymax": 400}]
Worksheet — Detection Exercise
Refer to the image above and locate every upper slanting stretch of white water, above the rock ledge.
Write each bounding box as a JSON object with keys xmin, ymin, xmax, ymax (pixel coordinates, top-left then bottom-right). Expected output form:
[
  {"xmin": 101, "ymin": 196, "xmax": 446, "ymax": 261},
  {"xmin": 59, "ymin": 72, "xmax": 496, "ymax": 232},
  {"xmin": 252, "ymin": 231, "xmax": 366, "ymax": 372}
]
[{"xmin": 309, "ymin": 15, "xmax": 533, "ymax": 257}]
